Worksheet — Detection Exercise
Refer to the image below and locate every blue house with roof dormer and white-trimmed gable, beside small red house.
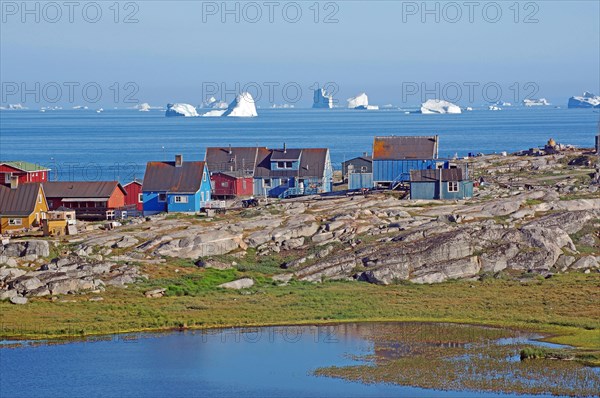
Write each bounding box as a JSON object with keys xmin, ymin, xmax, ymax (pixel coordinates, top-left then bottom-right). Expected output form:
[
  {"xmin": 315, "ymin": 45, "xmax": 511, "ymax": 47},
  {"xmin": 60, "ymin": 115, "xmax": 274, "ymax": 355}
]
[{"xmin": 254, "ymin": 145, "xmax": 333, "ymax": 198}]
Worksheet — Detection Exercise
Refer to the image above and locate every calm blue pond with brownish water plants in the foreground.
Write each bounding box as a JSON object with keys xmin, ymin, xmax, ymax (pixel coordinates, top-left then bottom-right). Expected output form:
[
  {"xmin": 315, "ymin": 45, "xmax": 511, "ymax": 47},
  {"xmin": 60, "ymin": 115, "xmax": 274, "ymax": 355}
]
[{"xmin": 0, "ymin": 323, "xmax": 600, "ymax": 397}]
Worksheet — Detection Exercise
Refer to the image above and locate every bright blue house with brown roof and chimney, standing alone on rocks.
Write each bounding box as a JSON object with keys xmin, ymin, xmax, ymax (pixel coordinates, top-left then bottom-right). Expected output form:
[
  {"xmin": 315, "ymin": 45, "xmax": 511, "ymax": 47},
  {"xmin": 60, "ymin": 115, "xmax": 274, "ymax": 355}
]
[{"xmin": 142, "ymin": 155, "xmax": 211, "ymax": 215}]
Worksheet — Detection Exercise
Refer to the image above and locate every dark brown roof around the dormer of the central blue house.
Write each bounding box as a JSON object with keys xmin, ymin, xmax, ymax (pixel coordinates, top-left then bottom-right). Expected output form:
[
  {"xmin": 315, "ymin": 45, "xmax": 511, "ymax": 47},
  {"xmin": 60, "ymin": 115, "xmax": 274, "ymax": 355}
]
[{"xmin": 254, "ymin": 148, "xmax": 328, "ymax": 178}]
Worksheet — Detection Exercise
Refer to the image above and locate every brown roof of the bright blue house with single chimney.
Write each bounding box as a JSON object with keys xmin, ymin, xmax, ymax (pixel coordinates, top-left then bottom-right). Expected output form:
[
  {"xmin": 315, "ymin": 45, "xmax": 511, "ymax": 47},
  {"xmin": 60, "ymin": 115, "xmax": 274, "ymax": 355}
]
[{"xmin": 142, "ymin": 162, "xmax": 205, "ymax": 193}]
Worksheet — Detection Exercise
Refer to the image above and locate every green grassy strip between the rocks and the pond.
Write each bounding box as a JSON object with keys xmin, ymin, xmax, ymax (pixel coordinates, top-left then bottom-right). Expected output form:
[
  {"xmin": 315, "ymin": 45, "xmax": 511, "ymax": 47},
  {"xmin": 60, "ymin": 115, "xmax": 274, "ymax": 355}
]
[{"xmin": 0, "ymin": 264, "xmax": 600, "ymax": 351}]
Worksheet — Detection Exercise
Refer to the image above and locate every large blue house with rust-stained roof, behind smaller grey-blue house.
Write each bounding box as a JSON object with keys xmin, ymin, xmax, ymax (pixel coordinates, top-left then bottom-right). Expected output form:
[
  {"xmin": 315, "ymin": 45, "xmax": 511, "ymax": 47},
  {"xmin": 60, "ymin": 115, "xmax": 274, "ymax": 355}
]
[{"xmin": 373, "ymin": 135, "xmax": 445, "ymax": 189}]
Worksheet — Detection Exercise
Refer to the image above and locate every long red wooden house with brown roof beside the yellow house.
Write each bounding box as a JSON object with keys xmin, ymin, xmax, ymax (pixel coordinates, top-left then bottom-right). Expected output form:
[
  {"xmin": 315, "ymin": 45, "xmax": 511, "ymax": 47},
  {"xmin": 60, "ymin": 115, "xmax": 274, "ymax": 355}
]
[{"xmin": 44, "ymin": 181, "xmax": 127, "ymax": 220}]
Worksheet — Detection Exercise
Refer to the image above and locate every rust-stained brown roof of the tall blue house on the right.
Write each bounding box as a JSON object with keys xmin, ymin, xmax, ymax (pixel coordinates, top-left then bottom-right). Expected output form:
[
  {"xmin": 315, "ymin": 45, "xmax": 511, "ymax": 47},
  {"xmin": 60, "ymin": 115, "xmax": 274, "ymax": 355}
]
[{"xmin": 373, "ymin": 136, "xmax": 438, "ymax": 160}]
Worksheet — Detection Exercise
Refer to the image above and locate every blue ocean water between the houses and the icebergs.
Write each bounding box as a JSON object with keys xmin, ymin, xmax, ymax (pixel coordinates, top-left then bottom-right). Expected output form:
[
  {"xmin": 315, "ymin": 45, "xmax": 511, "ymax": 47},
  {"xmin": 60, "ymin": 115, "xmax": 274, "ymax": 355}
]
[{"xmin": 0, "ymin": 108, "xmax": 600, "ymax": 182}]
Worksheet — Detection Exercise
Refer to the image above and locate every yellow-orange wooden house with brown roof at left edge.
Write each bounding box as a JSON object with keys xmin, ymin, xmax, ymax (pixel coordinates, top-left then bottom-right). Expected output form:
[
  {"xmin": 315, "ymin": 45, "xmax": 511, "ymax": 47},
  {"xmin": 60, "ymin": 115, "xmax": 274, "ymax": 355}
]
[{"xmin": 0, "ymin": 179, "xmax": 48, "ymax": 233}]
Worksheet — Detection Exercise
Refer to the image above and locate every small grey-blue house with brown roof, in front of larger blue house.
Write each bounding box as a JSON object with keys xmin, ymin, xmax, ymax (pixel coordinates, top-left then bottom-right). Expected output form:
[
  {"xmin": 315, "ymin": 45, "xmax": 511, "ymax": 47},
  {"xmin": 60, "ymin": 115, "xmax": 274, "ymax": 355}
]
[{"xmin": 410, "ymin": 168, "xmax": 473, "ymax": 200}]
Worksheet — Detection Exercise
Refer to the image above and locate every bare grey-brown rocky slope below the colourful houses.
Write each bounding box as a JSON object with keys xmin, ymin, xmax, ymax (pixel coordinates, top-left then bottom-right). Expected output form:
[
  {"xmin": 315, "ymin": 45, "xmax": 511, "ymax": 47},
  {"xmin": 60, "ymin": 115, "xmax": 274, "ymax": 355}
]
[{"xmin": 0, "ymin": 150, "xmax": 600, "ymax": 304}]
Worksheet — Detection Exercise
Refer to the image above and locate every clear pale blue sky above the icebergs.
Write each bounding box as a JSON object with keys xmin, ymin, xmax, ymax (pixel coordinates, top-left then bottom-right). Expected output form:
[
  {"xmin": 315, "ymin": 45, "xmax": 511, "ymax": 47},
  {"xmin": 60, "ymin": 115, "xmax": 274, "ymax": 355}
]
[{"xmin": 0, "ymin": 0, "xmax": 600, "ymax": 108}]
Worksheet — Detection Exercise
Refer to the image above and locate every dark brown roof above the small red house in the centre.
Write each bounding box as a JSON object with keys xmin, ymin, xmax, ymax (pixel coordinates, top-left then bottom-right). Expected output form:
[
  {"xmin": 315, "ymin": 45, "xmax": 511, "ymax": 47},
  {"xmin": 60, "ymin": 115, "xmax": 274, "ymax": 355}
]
[{"xmin": 205, "ymin": 147, "xmax": 267, "ymax": 174}]
